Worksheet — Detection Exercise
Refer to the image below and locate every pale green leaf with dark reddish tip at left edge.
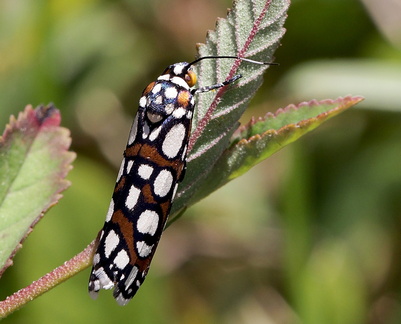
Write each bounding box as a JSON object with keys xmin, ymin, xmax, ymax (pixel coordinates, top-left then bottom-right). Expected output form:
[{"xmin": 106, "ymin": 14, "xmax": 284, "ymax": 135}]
[{"xmin": 0, "ymin": 105, "xmax": 75, "ymax": 275}]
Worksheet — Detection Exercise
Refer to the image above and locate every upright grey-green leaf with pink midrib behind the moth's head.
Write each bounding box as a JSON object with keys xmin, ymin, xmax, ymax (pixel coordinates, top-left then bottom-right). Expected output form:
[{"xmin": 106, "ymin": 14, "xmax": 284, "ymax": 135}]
[{"xmin": 171, "ymin": 0, "xmax": 289, "ymax": 215}]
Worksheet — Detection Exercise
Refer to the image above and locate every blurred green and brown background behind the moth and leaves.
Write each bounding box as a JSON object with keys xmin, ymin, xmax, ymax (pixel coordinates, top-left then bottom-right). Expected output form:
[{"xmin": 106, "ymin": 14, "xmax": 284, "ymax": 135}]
[{"xmin": 0, "ymin": 0, "xmax": 401, "ymax": 324}]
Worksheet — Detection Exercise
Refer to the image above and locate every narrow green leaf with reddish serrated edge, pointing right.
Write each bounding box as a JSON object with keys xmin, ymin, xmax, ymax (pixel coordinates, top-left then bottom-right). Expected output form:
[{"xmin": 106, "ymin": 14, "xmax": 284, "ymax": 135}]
[{"xmin": 184, "ymin": 97, "xmax": 363, "ymax": 208}]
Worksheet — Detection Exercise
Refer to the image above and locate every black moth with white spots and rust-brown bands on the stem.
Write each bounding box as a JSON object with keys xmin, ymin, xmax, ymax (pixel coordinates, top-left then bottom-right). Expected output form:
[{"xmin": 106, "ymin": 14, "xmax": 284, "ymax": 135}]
[{"xmin": 88, "ymin": 58, "xmax": 241, "ymax": 305}]
